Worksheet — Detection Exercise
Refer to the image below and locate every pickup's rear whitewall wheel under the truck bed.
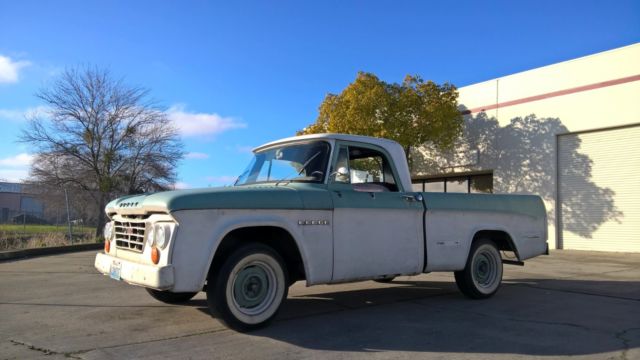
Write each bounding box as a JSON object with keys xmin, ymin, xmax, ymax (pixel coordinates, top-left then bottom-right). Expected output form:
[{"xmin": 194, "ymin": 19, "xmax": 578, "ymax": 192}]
[{"xmin": 454, "ymin": 239, "xmax": 502, "ymax": 299}]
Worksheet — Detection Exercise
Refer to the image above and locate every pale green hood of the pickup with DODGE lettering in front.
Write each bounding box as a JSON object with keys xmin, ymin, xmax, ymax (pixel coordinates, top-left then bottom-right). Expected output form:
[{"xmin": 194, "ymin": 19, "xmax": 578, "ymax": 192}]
[{"xmin": 106, "ymin": 185, "xmax": 331, "ymax": 214}]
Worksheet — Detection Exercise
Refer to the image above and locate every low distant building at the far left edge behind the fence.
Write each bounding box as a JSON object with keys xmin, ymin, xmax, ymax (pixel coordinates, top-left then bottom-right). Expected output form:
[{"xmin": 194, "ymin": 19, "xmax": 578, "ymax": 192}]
[{"xmin": 0, "ymin": 182, "xmax": 44, "ymax": 223}]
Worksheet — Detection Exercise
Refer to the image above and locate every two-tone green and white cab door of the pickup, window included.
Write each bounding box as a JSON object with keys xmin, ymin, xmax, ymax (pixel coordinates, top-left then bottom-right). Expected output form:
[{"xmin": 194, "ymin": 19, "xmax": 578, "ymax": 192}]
[{"xmin": 329, "ymin": 144, "xmax": 424, "ymax": 282}]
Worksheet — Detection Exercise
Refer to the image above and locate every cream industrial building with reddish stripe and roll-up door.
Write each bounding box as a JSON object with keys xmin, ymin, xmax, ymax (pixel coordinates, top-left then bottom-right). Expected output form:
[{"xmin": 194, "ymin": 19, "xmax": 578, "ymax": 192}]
[{"xmin": 413, "ymin": 43, "xmax": 640, "ymax": 252}]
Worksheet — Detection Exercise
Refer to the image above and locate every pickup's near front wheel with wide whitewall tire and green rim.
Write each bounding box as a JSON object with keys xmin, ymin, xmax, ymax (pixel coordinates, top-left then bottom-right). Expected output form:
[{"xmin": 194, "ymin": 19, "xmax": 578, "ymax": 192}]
[{"xmin": 207, "ymin": 243, "xmax": 289, "ymax": 331}]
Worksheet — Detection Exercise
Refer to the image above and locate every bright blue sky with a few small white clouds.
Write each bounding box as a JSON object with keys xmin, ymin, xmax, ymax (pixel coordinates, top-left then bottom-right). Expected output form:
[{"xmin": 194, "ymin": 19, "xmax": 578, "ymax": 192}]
[{"xmin": 0, "ymin": 0, "xmax": 640, "ymax": 187}]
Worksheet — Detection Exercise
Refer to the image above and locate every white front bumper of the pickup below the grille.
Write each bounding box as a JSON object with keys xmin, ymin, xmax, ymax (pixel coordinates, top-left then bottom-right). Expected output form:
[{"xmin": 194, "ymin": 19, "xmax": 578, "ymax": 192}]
[{"xmin": 95, "ymin": 253, "xmax": 175, "ymax": 290}]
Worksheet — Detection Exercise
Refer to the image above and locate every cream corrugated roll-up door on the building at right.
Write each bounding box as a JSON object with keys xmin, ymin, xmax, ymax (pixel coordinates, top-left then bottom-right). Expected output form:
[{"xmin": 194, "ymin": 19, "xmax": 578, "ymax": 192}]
[{"xmin": 557, "ymin": 125, "xmax": 640, "ymax": 252}]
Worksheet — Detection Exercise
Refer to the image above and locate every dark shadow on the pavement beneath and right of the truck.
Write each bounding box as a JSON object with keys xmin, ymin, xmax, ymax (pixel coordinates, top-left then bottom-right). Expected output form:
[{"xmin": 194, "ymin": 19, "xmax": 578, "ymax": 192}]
[{"xmin": 235, "ymin": 279, "xmax": 640, "ymax": 357}]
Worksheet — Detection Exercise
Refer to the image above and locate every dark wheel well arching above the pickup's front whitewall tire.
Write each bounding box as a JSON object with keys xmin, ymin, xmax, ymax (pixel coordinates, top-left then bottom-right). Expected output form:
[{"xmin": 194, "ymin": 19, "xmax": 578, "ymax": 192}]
[{"xmin": 209, "ymin": 226, "xmax": 306, "ymax": 283}]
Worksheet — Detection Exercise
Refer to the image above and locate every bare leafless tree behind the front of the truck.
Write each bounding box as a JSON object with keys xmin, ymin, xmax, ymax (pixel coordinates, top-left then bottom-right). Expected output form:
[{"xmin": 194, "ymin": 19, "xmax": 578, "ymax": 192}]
[{"xmin": 21, "ymin": 68, "xmax": 184, "ymax": 236}]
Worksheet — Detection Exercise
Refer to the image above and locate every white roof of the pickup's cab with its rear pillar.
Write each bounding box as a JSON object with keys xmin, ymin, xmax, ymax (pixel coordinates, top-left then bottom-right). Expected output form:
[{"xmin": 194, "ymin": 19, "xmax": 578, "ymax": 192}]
[{"xmin": 253, "ymin": 134, "xmax": 411, "ymax": 191}]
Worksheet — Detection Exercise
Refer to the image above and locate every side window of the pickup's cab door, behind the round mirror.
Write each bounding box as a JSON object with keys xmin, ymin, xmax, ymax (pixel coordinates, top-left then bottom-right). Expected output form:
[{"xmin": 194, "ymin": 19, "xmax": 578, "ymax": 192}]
[{"xmin": 334, "ymin": 146, "xmax": 398, "ymax": 192}]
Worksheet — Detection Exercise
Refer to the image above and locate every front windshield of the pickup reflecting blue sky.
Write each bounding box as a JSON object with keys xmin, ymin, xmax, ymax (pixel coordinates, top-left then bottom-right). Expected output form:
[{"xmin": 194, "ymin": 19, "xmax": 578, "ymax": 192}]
[{"xmin": 235, "ymin": 141, "xmax": 330, "ymax": 185}]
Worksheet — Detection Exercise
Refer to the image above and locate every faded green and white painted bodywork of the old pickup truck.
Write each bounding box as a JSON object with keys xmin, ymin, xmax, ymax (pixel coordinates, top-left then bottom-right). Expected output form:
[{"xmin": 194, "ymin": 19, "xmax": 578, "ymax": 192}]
[{"xmin": 96, "ymin": 135, "xmax": 546, "ymax": 292}]
